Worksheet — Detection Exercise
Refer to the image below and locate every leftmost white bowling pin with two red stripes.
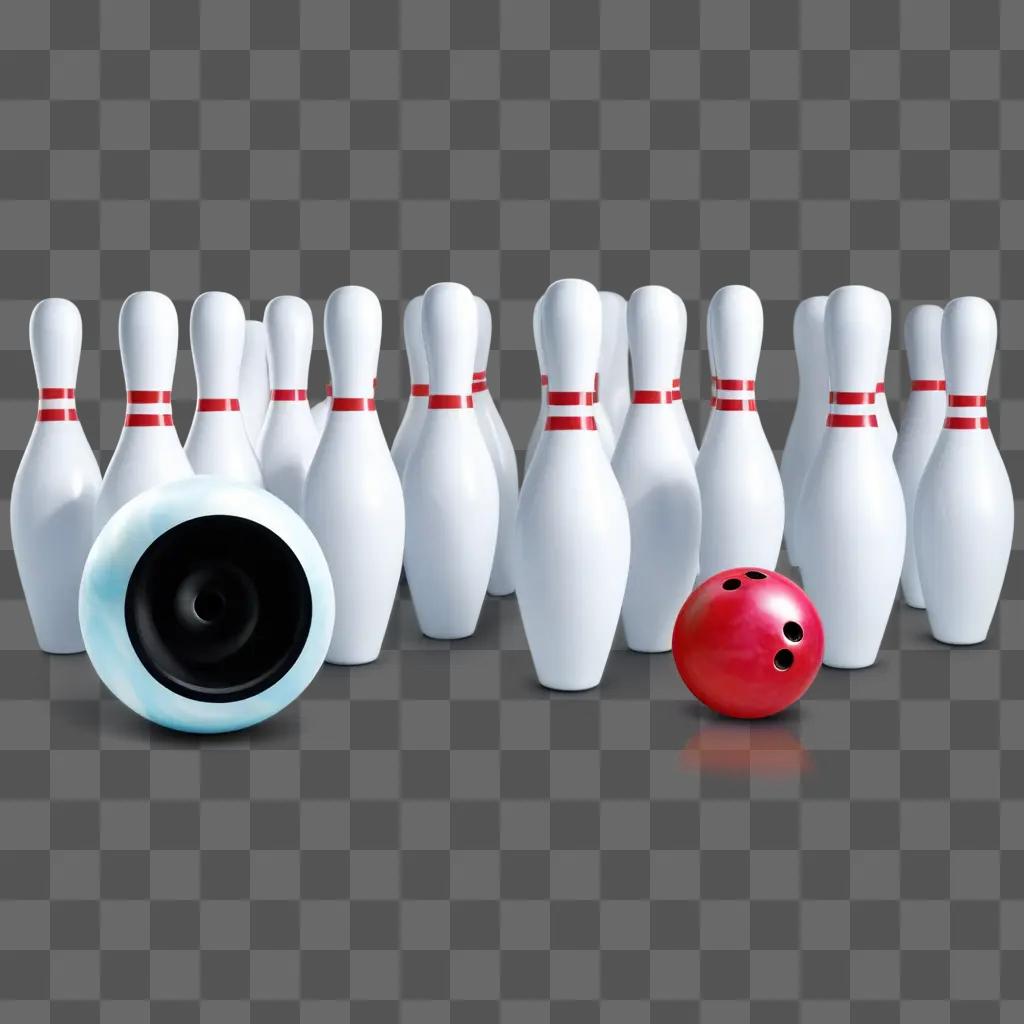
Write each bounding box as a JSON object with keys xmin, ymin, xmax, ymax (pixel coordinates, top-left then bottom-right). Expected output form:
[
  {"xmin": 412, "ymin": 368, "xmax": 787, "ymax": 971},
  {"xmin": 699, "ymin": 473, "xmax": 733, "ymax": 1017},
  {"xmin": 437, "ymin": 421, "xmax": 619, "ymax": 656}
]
[{"xmin": 10, "ymin": 299, "xmax": 99, "ymax": 654}]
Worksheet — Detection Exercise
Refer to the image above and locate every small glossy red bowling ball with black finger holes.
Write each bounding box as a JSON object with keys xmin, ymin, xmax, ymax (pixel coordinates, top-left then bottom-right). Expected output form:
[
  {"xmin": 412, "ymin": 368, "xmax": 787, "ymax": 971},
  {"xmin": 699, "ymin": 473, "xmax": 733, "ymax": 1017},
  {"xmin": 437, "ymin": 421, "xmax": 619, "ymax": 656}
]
[{"xmin": 672, "ymin": 566, "xmax": 824, "ymax": 718}]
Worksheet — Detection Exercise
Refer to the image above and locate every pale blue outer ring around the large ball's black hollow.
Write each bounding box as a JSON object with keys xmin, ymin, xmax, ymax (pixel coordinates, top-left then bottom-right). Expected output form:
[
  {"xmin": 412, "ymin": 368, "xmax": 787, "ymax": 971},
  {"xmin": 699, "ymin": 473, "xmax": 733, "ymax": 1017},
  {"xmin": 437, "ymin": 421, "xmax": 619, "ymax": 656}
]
[{"xmin": 79, "ymin": 476, "xmax": 334, "ymax": 733}]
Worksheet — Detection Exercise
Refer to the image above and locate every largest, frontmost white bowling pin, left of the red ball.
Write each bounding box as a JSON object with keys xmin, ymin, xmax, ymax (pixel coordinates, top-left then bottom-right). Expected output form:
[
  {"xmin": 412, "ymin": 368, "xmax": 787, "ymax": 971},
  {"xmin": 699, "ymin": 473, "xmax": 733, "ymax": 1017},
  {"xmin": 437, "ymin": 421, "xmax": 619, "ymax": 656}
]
[{"xmin": 515, "ymin": 280, "xmax": 630, "ymax": 690}]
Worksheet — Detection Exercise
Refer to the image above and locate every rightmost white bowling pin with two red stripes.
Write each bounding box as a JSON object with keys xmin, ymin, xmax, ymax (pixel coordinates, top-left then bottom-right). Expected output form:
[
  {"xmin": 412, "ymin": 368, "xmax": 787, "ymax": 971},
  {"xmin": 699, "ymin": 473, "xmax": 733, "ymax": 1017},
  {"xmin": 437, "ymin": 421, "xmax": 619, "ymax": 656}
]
[{"xmin": 913, "ymin": 297, "xmax": 1014, "ymax": 644}]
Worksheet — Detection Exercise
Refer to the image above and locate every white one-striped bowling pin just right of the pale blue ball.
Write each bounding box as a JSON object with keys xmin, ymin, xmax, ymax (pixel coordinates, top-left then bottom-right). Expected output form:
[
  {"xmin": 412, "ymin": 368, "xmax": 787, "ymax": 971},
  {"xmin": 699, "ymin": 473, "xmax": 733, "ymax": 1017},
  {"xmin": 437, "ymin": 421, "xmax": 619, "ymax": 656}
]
[{"xmin": 303, "ymin": 286, "xmax": 406, "ymax": 665}]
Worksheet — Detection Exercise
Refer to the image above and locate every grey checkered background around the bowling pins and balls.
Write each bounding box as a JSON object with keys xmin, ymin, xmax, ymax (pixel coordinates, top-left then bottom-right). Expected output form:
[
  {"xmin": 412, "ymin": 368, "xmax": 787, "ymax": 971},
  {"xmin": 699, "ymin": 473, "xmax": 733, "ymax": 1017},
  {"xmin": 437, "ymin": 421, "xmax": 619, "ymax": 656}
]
[{"xmin": 0, "ymin": 0, "xmax": 1024, "ymax": 1024}]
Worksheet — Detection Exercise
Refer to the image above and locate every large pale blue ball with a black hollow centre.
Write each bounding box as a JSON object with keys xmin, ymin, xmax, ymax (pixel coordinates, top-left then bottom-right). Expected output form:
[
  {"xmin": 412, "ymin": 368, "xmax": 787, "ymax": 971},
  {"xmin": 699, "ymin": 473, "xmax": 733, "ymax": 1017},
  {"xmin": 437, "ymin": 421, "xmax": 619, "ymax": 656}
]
[{"xmin": 79, "ymin": 476, "xmax": 334, "ymax": 732}]
